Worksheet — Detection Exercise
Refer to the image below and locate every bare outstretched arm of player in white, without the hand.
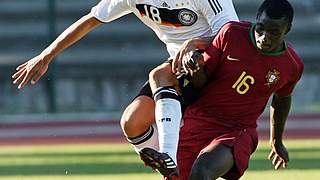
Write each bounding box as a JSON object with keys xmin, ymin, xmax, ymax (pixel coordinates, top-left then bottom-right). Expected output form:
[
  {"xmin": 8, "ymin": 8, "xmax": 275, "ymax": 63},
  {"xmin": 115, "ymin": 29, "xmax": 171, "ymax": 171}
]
[{"xmin": 41, "ymin": 14, "xmax": 102, "ymax": 61}]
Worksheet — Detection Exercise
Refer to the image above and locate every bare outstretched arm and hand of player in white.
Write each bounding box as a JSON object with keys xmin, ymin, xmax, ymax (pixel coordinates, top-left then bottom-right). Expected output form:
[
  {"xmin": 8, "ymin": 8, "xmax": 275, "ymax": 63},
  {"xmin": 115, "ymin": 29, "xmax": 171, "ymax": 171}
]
[{"xmin": 12, "ymin": 14, "xmax": 102, "ymax": 89}]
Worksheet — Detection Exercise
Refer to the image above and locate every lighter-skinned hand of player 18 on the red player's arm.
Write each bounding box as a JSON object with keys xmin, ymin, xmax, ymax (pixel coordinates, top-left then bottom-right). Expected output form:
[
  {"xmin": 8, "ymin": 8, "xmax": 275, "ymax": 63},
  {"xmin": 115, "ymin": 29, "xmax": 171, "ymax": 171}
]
[{"xmin": 172, "ymin": 39, "xmax": 196, "ymax": 74}]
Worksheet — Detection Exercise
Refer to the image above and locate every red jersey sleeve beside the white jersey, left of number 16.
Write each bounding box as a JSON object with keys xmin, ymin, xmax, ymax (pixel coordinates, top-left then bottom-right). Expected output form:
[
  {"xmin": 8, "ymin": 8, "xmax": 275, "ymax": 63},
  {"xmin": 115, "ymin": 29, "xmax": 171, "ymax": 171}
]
[{"xmin": 203, "ymin": 22, "xmax": 232, "ymax": 76}]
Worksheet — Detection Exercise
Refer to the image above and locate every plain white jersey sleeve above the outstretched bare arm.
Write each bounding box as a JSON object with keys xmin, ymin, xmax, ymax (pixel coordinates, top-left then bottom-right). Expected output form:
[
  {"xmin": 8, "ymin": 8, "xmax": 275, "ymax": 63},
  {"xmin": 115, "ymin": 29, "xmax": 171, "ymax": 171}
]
[{"xmin": 91, "ymin": 0, "xmax": 132, "ymax": 22}]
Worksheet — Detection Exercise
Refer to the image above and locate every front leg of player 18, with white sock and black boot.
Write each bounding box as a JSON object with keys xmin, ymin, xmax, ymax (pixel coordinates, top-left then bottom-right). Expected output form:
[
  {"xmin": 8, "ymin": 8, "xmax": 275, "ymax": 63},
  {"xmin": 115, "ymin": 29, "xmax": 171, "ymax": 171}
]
[{"xmin": 140, "ymin": 63, "xmax": 202, "ymax": 179}]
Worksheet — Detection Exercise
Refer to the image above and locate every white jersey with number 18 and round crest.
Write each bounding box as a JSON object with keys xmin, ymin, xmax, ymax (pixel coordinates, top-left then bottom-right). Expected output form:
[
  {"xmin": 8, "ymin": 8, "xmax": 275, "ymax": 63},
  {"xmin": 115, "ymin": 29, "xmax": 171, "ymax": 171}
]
[{"xmin": 91, "ymin": 0, "xmax": 239, "ymax": 58}]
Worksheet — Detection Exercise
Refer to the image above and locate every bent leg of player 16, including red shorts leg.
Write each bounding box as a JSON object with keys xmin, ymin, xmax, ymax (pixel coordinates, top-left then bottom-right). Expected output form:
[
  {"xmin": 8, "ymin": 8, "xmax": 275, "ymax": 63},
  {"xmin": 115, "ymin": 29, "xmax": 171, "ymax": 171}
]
[{"xmin": 190, "ymin": 128, "xmax": 258, "ymax": 180}]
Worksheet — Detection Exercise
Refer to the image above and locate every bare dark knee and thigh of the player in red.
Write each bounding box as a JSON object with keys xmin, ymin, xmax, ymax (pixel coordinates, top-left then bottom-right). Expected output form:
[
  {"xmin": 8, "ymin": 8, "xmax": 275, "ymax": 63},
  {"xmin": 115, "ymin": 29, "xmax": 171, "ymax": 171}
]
[{"xmin": 190, "ymin": 144, "xmax": 234, "ymax": 180}]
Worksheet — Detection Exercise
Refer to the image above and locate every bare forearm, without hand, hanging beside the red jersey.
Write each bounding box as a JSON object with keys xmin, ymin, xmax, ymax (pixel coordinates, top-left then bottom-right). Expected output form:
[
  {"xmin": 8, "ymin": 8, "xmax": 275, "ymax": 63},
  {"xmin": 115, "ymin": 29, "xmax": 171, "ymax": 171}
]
[{"xmin": 270, "ymin": 95, "xmax": 291, "ymax": 143}]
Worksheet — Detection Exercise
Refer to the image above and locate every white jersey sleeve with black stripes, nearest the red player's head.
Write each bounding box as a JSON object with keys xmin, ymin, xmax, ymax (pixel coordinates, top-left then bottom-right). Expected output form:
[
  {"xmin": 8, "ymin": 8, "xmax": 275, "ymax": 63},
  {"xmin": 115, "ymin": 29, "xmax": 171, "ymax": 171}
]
[{"xmin": 197, "ymin": 0, "xmax": 239, "ymax": 35}]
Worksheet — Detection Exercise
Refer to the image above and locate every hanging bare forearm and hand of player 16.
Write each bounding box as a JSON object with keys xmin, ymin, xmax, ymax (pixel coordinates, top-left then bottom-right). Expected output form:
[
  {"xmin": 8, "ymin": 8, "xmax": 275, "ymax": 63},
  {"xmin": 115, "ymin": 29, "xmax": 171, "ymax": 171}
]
[{"xmin": 268, "ymin": 94, "xmax": 291, "ymax": 169}]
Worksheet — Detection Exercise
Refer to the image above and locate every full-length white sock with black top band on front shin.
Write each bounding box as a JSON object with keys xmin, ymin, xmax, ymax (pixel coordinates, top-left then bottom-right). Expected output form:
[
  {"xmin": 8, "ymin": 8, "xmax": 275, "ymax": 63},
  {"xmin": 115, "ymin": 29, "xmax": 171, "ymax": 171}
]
[{"xmin": 154, "ymin": 87, "xmax": 182, "ymax": 164}]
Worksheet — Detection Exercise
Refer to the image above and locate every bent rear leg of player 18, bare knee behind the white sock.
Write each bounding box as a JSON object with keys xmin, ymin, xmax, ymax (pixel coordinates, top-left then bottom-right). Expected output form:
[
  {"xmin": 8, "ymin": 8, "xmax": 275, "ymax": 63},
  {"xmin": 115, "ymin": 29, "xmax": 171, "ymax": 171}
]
[{"xmin": 120, "ymin": 82, "xmax": 159, "ymax": 153}]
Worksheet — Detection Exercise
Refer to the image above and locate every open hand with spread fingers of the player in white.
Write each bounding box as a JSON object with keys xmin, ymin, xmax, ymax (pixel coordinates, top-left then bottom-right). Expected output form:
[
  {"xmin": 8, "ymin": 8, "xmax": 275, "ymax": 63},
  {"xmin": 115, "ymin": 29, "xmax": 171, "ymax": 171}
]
[{"xmin": 12, "ymin": 55, "xmax": 50, "ymax": 89}]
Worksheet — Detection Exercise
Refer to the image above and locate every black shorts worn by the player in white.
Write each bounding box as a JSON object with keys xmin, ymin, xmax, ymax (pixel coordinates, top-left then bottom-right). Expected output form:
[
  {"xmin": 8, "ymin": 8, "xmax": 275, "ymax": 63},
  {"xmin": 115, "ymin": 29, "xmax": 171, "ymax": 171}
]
[{"xmin": 134, "ymin": 60, "xmax": 199, "ymax": 109}]
